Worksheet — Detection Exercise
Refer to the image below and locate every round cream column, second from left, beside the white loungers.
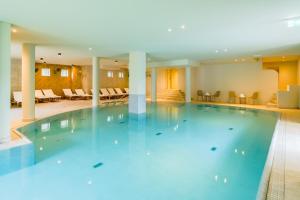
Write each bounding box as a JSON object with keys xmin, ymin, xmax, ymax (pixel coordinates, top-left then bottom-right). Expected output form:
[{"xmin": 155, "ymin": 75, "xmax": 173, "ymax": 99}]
[{"xmin": 22, "ymin": 44, "xmax": 35, "ymax": 121}]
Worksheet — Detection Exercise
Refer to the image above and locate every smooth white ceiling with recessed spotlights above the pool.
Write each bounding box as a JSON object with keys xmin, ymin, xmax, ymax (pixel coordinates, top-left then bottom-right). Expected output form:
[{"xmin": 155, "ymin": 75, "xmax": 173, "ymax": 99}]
[{"xmin": 0, "ymin": 0, "xmax": 300, "ymax": 65}]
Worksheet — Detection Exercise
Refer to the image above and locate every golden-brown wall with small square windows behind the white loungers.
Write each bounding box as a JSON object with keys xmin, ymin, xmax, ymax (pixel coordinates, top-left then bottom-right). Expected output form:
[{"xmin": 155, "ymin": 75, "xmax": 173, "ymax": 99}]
[{"xmin": 11, "ymin": 59, "xmax": 128, "ymax": 95}]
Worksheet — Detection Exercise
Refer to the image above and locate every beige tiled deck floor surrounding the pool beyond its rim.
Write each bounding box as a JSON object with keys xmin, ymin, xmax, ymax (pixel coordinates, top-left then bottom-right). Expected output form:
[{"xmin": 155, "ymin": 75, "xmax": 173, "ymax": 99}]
[{"xmin": 0, "ymin": 100, "xmax": 300, "ymax": 200}]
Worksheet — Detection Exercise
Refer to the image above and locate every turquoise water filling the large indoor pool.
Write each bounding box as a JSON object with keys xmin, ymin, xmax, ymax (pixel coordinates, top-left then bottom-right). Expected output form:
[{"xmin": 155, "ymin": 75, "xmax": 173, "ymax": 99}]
[{"xmin": 0, "ymin": 104, "xmax": 277, "ymax": 200}]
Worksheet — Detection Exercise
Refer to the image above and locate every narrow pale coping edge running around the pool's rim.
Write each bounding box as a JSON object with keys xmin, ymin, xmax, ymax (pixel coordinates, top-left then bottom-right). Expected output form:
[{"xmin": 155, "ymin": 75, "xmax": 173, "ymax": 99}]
[{"xmin": 0, "ymin": 101, "xmax": 282, "ymax": 200}]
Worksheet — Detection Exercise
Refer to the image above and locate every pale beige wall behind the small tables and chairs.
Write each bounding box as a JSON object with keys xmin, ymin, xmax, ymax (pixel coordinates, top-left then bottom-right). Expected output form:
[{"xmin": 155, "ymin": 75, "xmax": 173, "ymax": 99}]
[{"xmin": 192, "ymin": 63, "xmax": 278, "ymax": 103}]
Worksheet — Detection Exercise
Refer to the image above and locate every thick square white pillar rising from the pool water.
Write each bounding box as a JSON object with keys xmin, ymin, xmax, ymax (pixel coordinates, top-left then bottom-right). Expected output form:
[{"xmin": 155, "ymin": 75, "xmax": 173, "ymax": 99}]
[{"xmin": 129, "ymin": 52, "xmax": 146, "ymax": 114}]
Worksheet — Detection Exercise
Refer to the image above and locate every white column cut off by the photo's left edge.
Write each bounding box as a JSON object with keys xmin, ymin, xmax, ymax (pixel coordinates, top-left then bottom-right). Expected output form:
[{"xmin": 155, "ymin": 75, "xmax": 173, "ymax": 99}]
[{"xmin": 0, "ymin": 22, "xmax": 11, "ymax": 144}]
